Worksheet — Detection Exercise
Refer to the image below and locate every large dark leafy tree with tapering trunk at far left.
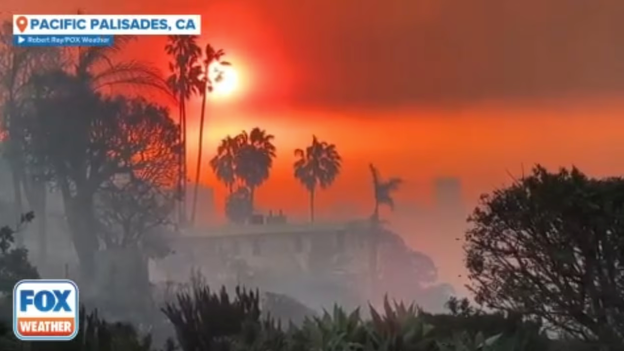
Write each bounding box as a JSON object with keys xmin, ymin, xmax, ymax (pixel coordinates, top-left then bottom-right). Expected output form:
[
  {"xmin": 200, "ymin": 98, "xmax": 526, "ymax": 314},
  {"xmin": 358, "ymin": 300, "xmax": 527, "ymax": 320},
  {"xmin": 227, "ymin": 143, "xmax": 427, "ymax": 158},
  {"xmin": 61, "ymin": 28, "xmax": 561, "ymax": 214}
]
[{"xmin": 29, "ymin": 88, "xmax": 169, "ymax": 279}]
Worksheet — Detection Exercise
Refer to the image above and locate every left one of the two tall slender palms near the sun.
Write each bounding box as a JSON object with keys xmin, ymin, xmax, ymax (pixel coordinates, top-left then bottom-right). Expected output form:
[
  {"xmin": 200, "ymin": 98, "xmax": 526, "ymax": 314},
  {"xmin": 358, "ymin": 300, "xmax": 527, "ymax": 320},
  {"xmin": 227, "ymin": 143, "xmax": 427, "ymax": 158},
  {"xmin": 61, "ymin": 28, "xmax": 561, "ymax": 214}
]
[{"xmin": 165, "ymin": 35, "xmax": 202, "ymax": 226}]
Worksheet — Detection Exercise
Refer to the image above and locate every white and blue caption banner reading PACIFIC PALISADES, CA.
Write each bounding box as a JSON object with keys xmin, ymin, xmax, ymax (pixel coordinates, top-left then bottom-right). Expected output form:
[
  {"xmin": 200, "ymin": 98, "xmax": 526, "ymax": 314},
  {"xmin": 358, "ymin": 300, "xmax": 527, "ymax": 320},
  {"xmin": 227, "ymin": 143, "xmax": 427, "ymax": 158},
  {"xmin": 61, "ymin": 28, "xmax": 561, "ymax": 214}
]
[{"xmin": 13, "ymin": 15, "xmax": 201, "ymax": 47}]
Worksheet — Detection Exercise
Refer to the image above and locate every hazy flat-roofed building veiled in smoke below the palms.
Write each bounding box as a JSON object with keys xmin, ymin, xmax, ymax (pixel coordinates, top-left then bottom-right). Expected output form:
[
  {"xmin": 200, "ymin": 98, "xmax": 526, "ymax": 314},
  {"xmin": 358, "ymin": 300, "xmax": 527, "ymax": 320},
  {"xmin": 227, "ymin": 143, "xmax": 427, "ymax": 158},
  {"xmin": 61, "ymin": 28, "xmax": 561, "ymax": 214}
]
[{"xmin": 151, "ymin": 212, "xmax": 371, "ymax": 307}]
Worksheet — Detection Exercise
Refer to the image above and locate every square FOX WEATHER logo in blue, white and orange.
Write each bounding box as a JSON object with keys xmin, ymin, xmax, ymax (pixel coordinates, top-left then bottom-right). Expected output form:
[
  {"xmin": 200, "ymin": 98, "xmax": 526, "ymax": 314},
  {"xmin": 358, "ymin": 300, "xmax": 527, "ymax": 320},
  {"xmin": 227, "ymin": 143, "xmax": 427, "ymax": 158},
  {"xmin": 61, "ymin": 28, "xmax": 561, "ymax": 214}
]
[{"xmin": 13, "ymin": 279, "xmax": 79, "ymax": 341}]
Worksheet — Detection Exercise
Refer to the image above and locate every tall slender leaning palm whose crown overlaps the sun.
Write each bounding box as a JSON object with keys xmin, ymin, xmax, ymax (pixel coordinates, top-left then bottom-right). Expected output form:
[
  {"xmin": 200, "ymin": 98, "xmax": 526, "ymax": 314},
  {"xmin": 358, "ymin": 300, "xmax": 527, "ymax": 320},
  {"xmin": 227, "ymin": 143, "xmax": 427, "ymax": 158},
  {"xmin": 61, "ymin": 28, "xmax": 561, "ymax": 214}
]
[{"xmin": 191, "ymin": 44, "xmax": 229, "ymax": 224}]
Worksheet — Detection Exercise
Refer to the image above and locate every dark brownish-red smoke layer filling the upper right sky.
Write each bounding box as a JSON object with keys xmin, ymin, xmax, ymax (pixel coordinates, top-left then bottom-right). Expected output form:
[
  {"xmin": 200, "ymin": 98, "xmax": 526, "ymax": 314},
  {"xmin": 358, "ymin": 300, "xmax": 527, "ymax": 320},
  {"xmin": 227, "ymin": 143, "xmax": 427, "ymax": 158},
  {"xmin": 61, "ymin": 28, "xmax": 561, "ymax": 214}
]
[{"xmin": 241, "ymin": 0, "xmax": 624, "ymax": 109}]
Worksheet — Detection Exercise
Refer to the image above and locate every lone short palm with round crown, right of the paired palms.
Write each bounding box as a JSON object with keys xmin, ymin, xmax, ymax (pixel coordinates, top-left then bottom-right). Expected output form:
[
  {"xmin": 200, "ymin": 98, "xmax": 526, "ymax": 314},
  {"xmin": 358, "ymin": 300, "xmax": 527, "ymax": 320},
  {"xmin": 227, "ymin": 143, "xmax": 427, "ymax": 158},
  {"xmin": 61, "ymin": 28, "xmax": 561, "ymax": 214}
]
[{"xmin": 294, "ymin": 136, "xmax": 342, "ymax": 222}]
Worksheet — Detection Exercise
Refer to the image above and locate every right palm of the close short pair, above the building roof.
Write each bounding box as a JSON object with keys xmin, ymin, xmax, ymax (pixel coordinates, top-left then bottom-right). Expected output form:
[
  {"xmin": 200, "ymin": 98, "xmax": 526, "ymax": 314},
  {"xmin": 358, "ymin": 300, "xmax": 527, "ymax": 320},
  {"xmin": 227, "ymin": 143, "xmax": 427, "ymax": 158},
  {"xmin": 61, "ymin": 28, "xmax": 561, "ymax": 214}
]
[{"xmin": 235, "ymin": 127, "xmax": 276, "ymax": 206}]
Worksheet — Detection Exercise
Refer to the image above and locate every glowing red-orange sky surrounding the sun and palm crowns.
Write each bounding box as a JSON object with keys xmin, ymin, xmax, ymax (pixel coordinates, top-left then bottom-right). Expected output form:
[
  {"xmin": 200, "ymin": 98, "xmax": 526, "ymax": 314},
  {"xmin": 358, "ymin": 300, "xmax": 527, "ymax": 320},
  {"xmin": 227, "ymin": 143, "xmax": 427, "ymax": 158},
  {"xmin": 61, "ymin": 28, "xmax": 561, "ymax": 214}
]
[{"xmin": 7, "ymin": 0, "xmax": 624, "ymax": 294}]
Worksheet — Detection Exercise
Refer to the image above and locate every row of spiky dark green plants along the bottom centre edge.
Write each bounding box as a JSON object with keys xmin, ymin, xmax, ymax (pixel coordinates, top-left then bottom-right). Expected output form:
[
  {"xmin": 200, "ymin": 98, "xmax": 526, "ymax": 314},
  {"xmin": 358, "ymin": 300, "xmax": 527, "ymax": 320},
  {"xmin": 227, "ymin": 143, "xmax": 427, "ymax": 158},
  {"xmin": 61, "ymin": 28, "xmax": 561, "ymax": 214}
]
[{"xmin": 163, "ymin": 284, "xmax": 569, "ymax": 351}]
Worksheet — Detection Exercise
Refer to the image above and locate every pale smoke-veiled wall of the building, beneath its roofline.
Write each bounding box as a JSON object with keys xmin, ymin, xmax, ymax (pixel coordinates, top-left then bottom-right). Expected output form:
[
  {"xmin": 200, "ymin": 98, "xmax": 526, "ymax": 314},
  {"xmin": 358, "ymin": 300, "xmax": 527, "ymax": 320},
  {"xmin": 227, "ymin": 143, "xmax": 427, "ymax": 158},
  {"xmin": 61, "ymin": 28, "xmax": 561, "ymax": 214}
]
[{"xmin": 152, "ymin": 224, "xmax": 370, "ymax": 288}]
